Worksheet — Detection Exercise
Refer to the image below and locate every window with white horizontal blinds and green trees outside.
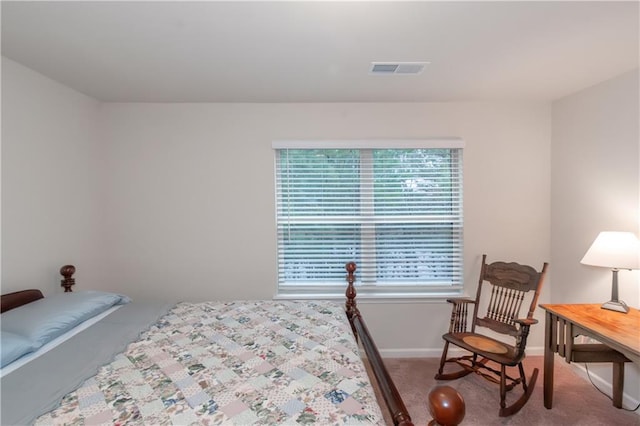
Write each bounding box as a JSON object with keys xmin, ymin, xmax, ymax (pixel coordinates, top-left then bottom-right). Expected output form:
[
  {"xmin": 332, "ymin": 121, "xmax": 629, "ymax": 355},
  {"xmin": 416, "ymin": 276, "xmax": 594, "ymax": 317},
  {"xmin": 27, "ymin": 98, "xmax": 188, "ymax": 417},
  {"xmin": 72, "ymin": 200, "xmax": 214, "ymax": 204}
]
[{"xmin": 273, "ymin": 139, "xmax": 463, "ymax": 297}]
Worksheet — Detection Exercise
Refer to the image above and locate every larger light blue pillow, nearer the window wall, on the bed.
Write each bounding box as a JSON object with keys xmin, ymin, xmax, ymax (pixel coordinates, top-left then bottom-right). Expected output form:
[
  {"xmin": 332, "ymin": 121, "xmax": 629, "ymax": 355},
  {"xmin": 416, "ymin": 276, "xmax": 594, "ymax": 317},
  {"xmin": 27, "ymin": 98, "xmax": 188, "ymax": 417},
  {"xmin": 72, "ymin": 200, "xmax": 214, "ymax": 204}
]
[{"xmin": 0, "ymin": 291, "xmax": 131, "ymax": 349}]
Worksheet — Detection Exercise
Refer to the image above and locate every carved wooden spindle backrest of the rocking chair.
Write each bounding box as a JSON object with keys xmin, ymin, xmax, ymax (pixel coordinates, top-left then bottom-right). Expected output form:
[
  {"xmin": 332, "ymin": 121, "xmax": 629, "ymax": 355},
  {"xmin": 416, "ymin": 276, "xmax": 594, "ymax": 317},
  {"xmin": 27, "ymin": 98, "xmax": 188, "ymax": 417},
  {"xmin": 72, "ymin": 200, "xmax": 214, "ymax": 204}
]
[{"xmin": 472, "ymin": 255, "xmax": 548, "ymax": 337}]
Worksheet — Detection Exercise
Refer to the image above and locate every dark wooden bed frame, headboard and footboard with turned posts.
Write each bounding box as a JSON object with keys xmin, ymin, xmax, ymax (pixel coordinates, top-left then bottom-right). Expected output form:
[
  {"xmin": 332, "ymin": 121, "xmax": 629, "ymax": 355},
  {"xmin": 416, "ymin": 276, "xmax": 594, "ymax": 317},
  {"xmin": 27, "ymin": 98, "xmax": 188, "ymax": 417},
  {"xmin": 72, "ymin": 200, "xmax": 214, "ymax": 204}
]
[{"xmin": 0, "ymin": 262, "xmax": 413, "ymax": 426}]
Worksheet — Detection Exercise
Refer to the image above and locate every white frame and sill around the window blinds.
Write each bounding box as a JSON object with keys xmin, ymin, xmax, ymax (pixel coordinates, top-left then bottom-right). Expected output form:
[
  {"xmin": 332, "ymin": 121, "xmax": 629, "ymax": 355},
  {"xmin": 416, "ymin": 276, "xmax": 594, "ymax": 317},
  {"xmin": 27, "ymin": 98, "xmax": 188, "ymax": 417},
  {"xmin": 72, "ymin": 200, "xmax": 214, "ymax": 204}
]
[{"xmin": 272, "ymin": 138, "xmax": 465, "ymax": 302}]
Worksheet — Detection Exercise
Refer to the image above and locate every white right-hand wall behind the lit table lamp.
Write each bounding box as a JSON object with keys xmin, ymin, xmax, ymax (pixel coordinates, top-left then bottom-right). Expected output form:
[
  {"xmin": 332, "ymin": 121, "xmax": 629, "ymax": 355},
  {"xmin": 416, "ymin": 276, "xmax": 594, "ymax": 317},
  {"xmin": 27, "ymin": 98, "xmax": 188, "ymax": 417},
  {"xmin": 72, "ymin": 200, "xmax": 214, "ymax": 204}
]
[{"xmin": 551, "ymin": 70, "xmax": 640, "ymax": 401}]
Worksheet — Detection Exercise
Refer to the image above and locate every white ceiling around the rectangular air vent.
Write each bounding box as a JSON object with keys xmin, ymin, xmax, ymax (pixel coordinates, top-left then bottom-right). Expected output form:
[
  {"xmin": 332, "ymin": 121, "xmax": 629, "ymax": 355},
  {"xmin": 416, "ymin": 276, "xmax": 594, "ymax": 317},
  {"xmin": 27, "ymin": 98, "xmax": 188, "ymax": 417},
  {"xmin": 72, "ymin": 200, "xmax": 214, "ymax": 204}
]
[{"xmin": 1, "ymin": 1, "xmax": 640, "ymax": 102}]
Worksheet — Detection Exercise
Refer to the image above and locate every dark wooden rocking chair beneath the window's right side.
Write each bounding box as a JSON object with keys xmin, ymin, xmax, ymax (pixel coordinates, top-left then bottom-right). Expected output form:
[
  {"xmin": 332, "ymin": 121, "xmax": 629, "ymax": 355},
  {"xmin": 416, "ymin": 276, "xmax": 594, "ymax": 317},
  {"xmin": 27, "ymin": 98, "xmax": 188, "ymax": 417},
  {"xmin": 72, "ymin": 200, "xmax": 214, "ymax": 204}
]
[{"xmin": 435, "ymin": 255, "xmax": 548, "ymax": 417}]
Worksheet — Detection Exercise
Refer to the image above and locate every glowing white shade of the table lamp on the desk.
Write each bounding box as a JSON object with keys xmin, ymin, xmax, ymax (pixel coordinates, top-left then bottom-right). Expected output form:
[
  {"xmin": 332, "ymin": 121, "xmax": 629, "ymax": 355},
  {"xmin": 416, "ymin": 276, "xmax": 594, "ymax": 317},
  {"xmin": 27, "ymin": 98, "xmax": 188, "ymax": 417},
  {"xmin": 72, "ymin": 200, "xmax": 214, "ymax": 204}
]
[{"xmin": 580, "ymin": 231, "xmax": 640, "ymax": 269}]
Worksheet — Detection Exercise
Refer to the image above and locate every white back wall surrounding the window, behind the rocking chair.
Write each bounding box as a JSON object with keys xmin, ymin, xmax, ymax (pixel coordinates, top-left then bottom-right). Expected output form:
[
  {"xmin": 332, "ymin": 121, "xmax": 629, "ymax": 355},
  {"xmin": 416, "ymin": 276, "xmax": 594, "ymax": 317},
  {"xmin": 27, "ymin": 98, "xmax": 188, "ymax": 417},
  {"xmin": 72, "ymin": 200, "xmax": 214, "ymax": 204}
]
[{"xmin": 102, "ymin": 103, "xmax": 550, "ymax": 352}]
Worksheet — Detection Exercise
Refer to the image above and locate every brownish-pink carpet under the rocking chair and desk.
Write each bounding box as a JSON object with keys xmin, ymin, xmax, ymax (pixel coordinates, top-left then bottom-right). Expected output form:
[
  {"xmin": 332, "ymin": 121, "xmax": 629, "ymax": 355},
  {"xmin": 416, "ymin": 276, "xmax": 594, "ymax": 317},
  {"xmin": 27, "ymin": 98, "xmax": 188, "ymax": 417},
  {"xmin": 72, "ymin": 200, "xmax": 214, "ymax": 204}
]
[{"xmin": 384, "ymin": 356, "xmax": 640, "ymax": 426}]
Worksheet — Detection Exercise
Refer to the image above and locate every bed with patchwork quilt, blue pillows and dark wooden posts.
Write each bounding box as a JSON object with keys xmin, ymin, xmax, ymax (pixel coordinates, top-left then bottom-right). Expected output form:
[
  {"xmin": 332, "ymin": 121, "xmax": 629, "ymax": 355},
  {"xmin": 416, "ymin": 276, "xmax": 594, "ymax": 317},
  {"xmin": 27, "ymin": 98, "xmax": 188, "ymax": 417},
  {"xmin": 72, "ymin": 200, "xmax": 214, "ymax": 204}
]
[{"xmin": 0, "ymin": 263, "xmax": 412, "ymax": 425}]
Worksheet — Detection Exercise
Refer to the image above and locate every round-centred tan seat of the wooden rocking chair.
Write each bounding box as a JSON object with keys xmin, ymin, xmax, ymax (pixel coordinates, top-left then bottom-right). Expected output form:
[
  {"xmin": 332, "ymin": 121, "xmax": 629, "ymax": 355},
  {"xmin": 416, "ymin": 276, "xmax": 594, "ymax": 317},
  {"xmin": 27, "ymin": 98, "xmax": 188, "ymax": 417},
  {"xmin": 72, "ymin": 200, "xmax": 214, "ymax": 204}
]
[{"xmin": 442, "ymin": 333, "xmax": 524, "ymax": 366}]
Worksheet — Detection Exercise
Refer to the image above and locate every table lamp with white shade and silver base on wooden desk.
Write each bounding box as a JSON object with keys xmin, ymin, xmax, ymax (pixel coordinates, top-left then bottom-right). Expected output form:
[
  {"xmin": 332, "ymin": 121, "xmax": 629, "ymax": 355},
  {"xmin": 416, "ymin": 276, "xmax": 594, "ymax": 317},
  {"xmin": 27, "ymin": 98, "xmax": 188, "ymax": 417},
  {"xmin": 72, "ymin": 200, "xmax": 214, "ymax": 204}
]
[{"xmin": 580, "ymin": 231, "xmax": 640, "ymax": 314}]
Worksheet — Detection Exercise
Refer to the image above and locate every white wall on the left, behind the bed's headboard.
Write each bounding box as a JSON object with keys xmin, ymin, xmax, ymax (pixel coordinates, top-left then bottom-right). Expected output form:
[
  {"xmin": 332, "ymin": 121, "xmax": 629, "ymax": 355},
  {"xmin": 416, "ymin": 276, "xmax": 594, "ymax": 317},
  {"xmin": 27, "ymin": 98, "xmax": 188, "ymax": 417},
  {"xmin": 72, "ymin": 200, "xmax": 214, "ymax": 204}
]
[{"xmin": 2, "ymin": 57, "xmax": 103, "ymax": 295}]
